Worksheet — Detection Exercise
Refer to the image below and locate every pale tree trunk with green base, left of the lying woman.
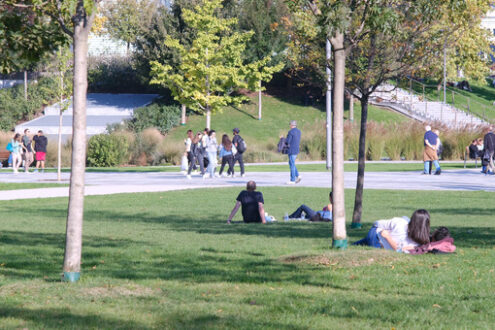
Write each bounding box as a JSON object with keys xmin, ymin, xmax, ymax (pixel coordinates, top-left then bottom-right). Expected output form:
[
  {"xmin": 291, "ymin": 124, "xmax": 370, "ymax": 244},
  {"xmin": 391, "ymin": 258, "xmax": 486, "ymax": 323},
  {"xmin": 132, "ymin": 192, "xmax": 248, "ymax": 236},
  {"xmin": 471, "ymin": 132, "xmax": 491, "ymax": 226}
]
[{"xmin": 331, "ymin": 33, "xmax": 347, "ymax": 249}]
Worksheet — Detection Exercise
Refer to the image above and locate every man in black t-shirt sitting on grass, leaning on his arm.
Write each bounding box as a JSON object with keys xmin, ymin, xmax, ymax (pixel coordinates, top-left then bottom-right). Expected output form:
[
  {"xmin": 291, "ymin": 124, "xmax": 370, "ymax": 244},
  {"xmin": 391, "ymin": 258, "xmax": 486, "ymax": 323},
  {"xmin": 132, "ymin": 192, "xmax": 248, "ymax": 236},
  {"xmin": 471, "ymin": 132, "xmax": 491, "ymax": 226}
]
[{"xmin": 227, "ymin": 181, "xmax": 266, "ymax": 224}]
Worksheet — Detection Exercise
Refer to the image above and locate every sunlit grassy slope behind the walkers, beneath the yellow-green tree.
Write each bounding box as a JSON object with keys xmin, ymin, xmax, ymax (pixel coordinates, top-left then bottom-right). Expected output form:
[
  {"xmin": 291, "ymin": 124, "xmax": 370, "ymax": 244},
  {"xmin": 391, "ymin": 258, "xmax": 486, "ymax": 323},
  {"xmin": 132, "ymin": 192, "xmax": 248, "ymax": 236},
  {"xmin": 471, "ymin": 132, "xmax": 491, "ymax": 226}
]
[{"xmin": 167, "ymin": 95, "xmax": 409, "ymax": 144}]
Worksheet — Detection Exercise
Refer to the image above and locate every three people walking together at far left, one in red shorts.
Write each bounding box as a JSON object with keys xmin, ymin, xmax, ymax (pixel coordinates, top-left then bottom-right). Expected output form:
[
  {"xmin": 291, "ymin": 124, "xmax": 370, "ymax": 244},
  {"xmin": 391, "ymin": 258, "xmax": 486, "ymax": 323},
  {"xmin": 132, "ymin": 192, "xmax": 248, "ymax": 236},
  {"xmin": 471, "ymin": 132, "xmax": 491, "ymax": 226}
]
[{"xmin": 6, "ymin": 129, "xmax": 48, "ymax": 174}]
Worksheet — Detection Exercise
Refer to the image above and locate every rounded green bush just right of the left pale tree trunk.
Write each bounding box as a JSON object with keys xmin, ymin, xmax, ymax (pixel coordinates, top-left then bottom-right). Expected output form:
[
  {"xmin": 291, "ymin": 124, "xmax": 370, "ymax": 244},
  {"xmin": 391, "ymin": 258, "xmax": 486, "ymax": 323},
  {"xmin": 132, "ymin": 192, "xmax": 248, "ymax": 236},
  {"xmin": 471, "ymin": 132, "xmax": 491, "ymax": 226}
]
[{"xmin": 87, "ymin": 133, "xmax": 130, "ymax": 167}]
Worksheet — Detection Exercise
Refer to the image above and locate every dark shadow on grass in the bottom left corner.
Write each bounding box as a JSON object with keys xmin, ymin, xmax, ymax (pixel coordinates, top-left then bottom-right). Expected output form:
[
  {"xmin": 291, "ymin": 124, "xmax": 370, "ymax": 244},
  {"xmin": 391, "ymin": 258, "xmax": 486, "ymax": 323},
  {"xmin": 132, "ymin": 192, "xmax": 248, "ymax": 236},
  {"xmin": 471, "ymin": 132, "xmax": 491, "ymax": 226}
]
[{"xmin": 0, "ymin": 306, "xmax": 146, "ymax": 329}]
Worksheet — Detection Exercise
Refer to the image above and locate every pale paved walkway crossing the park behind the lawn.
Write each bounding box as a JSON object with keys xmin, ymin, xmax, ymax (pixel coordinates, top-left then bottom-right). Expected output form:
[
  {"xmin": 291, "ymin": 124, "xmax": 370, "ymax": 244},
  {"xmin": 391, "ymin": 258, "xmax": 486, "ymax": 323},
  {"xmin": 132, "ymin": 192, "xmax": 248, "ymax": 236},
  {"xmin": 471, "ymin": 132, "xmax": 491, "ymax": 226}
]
[{"xmin": 0, "ymin": 169, "xmax": 495, "ymax": 200}]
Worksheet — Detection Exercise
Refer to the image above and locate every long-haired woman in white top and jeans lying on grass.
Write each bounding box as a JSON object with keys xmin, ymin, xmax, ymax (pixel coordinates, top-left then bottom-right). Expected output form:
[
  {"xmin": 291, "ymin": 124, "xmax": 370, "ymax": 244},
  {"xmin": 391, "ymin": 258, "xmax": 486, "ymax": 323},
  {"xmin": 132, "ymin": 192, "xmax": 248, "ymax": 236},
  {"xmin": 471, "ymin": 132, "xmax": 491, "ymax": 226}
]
[{"xmin": 353, "ymin": 209, "xmax": 430, "ymax": 253}]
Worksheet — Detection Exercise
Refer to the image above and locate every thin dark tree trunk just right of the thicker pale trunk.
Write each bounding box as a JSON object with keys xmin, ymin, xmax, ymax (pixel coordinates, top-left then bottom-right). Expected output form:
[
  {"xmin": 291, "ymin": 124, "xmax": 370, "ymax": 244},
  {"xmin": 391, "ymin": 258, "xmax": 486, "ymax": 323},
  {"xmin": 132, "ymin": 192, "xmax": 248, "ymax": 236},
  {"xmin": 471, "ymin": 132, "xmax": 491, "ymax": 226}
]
[{"xmin": 351, "ymin": 95, "xmax": 368, "ymax": 228}]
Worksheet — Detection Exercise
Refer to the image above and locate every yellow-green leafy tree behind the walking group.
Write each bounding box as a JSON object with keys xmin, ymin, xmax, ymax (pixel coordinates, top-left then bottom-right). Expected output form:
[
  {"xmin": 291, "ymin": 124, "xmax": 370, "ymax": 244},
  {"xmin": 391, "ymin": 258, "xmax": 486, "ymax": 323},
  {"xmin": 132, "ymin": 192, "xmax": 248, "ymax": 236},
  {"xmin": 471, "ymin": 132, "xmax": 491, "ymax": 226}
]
[{"xmin": 151, "ymin": 0, "xmax": 260, "ymax": 128}]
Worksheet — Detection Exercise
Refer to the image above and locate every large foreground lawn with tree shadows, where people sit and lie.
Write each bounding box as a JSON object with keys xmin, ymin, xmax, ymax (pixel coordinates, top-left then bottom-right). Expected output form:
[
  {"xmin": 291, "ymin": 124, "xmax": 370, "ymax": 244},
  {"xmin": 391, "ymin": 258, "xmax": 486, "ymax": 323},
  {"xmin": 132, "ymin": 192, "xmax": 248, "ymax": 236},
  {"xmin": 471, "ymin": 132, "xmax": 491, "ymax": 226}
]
[{"xmin": 0, "ymin": 187, "xmax": 495, "ymax": 329}]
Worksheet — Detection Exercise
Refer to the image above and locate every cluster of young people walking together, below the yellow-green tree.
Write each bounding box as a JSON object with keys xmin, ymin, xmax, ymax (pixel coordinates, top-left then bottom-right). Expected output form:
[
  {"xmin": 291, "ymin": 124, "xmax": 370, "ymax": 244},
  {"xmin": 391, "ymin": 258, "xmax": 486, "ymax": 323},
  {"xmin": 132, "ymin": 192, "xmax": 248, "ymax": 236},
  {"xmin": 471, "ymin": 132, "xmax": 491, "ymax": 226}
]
[{"xmin": 184, "ymin": 127, "xmax": 246, "ymax": 179}]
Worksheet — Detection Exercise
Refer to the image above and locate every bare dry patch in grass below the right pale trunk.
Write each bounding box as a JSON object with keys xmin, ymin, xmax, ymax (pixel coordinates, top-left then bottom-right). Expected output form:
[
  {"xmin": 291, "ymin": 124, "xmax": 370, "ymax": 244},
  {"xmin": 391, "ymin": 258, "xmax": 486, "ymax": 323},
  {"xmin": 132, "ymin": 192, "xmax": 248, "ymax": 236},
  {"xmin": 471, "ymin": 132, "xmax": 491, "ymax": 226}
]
[{"xmin": 279, "ymin": 249, "xmax": 405, "ymax": 268}]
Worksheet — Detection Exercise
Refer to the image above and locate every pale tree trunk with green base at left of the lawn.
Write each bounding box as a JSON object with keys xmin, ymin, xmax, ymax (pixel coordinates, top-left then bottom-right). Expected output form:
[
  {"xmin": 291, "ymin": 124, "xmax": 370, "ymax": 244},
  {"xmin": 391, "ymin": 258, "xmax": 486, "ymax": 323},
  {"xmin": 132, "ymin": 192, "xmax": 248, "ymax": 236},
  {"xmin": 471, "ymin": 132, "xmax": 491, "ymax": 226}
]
[{"xmin": 63, "ymin": 0, "xmax": 94, "ymax": 282}]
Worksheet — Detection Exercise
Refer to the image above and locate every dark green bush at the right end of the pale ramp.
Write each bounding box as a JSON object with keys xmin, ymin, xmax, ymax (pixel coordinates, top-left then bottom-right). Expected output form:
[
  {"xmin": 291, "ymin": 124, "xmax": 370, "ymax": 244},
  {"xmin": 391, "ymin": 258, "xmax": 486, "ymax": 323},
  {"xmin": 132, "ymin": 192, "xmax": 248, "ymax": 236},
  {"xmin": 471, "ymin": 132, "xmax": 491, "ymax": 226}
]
[{"xmin": 129, "ymin": 103, "xmax": 181, "ymax": 134}]
